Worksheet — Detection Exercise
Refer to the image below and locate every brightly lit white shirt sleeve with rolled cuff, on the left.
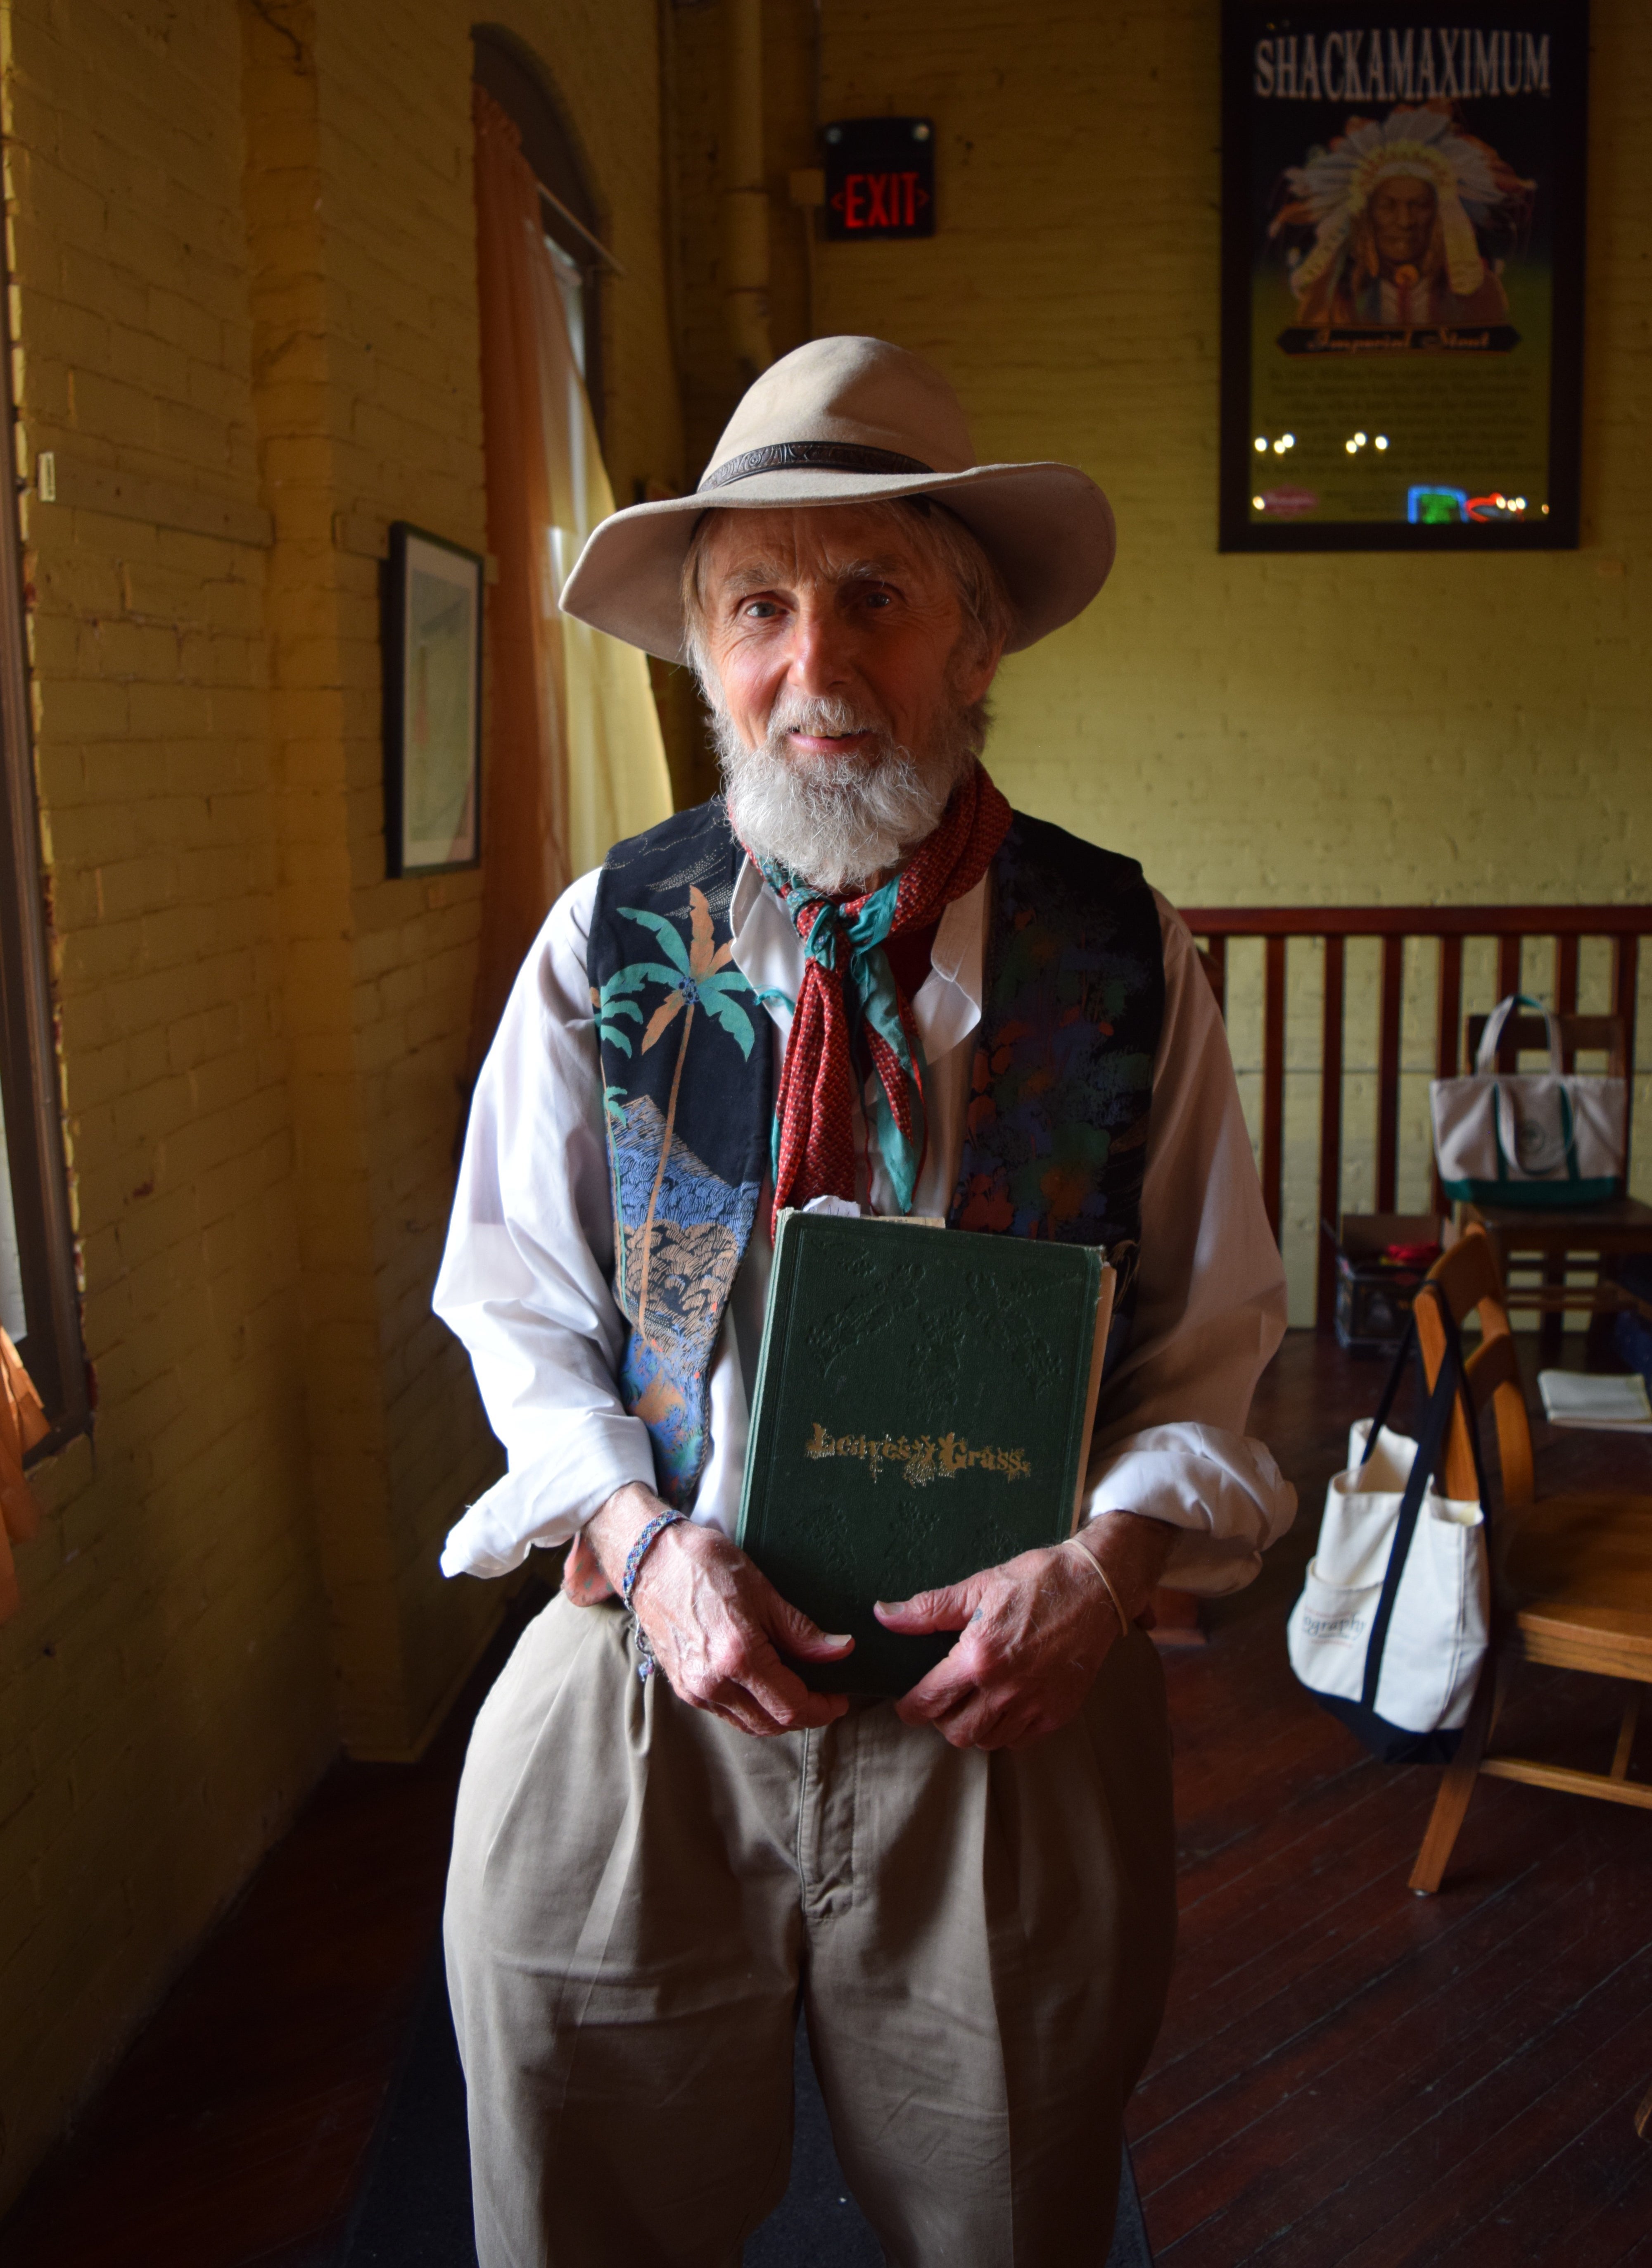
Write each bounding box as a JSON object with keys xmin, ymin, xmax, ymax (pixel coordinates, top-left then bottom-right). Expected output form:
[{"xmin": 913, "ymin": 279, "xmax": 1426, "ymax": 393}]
[{"xmin": 433, "ymin": 873, "xmax": 655, "ymax": 1576}]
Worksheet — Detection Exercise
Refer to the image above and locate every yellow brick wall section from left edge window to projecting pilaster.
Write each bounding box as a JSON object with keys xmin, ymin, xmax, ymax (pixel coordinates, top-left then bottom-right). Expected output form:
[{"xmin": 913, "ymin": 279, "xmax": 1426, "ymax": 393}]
[{"xmin": 0, "ymin": 0, "xmax": 335, "ymax": 2198}]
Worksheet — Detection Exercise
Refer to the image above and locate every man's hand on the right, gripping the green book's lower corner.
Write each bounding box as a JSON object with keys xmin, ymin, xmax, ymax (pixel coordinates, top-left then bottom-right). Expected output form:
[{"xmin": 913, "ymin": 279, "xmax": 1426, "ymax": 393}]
[{"xmin": 875, "ymin": 1513, "xmax": 1174, "ymax": 1749}]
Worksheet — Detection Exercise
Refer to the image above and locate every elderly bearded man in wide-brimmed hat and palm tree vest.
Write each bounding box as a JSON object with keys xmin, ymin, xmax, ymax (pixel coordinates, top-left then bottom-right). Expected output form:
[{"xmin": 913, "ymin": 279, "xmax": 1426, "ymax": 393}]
[{"xmin": 437, "ymin": 338, "xmax": 1294, "ymax": 2268}]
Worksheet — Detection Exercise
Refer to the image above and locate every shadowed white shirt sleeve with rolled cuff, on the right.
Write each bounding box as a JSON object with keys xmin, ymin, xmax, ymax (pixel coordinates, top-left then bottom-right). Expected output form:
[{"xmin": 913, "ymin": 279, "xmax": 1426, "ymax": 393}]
[{"xmin": 1085, "ymin": 898, "xmax": 1296, "ymax": 1594}]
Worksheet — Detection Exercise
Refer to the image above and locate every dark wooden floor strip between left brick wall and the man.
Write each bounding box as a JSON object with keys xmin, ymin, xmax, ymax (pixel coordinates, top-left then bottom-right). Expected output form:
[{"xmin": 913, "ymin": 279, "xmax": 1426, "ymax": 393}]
[{"xmin": 0, "ymin": 1586, "xmax": 546, "ymax": 2268}]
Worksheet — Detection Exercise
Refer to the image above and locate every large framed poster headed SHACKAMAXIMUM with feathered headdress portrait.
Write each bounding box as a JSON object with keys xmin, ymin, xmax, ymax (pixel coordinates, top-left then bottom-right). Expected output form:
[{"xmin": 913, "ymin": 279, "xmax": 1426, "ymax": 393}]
[{"xmin": 1221, "ymin": 0, "xmax": 1588, "ymax": 551}]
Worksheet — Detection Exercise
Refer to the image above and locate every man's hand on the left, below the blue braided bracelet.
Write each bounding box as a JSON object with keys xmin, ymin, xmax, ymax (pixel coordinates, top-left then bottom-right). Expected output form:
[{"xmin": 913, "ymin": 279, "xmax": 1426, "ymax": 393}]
[{"xmin": 582, "ymin": 1483, "xmax": 852, "ymax": 1733}]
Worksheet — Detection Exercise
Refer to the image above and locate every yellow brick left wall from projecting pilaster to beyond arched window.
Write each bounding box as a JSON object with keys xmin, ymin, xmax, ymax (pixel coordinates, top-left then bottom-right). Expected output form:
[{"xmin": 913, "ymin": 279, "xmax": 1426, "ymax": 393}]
[{"xmin": 247, "ymin": 0, "xmax": 682, "ymax": 1755}]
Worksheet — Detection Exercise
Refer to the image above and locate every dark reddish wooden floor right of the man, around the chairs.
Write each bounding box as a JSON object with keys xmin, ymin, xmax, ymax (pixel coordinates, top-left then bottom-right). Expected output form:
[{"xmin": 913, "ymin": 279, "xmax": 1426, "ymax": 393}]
[{"xmin": 1129, "ymin": 1334, "xmax": 1652, "ymax": 2268}]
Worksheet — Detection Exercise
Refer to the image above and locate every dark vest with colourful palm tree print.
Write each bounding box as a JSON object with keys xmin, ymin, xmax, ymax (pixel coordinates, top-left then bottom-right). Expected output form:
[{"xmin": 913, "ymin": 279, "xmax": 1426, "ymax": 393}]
[{"xmin": 589, "ymin": 798, "xmax": 1165, "ymax": 1508}]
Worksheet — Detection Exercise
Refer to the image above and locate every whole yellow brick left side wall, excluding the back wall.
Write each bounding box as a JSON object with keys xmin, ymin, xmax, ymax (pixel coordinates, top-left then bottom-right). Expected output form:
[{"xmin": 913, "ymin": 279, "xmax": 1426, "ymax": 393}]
[{"xmin": 0, "ymin": 0, "xmax": 684, "ymax": 2209}]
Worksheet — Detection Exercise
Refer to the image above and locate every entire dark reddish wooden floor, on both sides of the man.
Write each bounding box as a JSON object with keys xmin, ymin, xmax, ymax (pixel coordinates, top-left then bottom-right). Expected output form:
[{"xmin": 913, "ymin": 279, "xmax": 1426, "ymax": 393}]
[{"xmin": 0, "ymin": 1334, "xmax": 1652, "ymax": 2268}]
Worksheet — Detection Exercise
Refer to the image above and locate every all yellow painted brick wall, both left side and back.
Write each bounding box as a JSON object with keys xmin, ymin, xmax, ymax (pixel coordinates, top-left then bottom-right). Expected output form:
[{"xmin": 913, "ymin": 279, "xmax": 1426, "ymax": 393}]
[{"xmin": 0, "ymin": 0, "xmax": 1652, "ymax": 2209}]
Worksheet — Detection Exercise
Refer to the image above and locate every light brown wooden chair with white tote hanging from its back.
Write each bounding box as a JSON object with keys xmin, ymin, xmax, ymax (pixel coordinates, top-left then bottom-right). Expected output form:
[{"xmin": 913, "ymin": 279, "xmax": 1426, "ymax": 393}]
[{"xmin": 1412, "ymin": 1229, "xmax": 1652, "ymax": 1896}]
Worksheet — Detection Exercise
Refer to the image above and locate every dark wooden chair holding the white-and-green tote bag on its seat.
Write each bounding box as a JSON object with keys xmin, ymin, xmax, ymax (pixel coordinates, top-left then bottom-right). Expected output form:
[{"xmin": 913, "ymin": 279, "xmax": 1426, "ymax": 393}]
[{"xmin": 1460, "ymin": 1016, "xmax": 1652, "ymax": 1363}]
